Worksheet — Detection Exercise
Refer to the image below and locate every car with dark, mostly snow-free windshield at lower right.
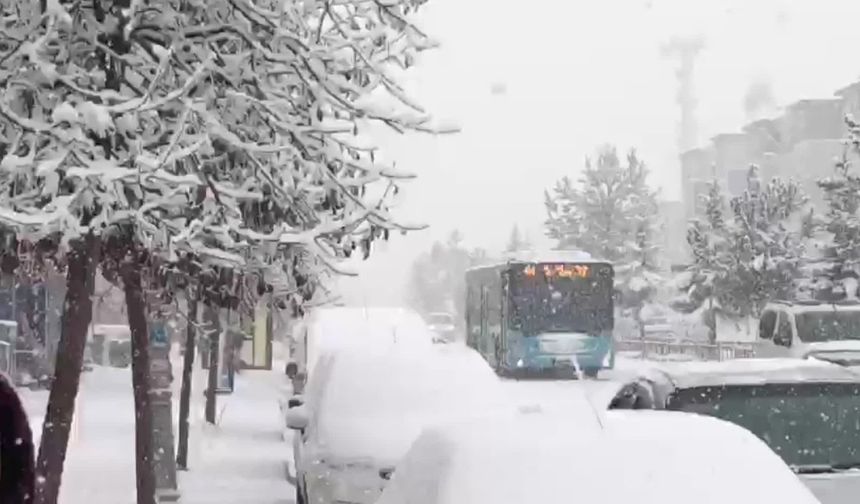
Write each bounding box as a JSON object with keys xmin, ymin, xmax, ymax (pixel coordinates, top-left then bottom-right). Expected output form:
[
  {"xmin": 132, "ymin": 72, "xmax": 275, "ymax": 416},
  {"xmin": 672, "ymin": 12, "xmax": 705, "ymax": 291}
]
[{"xmin": 610, "ymin": 359, "xmax": 860, "ymax": 504}]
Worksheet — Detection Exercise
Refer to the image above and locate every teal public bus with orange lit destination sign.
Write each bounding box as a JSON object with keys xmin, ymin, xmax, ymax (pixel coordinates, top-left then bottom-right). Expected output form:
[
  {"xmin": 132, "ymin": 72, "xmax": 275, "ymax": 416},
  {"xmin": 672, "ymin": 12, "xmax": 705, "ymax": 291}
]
[{"xmin": 466, "ymin": 251, "xmax": 615, "ymax": 377}]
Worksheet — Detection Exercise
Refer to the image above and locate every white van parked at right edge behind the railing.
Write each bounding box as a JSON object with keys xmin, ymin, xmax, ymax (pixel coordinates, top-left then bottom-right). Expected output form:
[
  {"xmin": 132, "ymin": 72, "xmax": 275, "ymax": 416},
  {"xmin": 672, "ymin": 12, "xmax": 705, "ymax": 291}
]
[{"xmin": 756, "ymin": 301, "xmax": 860, "ymax": 363}]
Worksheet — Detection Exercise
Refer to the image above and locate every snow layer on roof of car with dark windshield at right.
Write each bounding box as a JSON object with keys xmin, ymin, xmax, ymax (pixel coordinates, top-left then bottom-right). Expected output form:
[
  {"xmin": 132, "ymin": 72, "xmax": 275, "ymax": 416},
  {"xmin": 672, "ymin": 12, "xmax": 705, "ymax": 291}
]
[{"xmin": 645, "ymin": 358, "xmax": 860, "ymax": 388}]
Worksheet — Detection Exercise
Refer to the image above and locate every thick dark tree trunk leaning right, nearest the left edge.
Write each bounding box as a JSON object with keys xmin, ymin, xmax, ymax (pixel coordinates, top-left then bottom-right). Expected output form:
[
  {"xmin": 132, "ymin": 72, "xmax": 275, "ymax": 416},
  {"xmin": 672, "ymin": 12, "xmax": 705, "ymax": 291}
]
[{"xmin": 33, "ymin": 234, "xmax": 100, "ymax": 504}]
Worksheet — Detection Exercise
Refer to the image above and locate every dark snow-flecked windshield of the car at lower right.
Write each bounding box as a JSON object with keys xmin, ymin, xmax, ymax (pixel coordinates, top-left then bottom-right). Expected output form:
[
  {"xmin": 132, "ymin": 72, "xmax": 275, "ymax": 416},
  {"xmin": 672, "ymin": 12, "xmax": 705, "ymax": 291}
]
[{"xmin": 668, "ymin": 383, "xmax": 860, "ymax": 468}]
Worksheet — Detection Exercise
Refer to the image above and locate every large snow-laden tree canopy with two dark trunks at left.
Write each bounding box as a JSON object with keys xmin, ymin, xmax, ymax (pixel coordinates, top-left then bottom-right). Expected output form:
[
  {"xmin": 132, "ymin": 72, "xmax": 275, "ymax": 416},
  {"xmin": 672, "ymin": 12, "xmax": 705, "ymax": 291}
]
[{"xmin": 0, "ymin": 0, "xmax": 450, "ymax": 504}]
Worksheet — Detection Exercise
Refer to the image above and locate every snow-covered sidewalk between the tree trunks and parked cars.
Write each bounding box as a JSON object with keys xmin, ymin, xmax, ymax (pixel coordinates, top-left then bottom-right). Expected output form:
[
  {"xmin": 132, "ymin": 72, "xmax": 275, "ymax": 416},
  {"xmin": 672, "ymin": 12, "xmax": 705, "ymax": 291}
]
[{"xmin": 21, "ymin": 363, "xmax": 295, "ymax": 504}]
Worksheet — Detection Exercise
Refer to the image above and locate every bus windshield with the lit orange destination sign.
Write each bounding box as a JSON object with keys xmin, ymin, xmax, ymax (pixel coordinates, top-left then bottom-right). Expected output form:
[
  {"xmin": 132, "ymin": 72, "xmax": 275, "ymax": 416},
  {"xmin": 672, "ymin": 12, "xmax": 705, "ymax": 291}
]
[{"xmin": 509, "ymin": 264, "xmax": 613, "ymax": 335}]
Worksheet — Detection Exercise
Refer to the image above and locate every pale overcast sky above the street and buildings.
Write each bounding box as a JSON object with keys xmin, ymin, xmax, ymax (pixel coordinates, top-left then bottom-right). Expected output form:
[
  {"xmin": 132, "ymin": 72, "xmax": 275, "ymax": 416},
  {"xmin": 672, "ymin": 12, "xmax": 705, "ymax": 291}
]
[{"xmin": 340, "ymin": 0, "xmax": 860, "ymax": 304}]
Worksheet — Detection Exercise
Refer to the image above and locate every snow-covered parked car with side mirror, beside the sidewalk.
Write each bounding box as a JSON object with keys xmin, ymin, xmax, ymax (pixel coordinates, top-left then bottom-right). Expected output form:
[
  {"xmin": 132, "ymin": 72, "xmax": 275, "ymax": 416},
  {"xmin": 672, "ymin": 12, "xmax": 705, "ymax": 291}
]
[{"xmin": 286, "ymin": 345, "xmax": 511, "ymax": 504}]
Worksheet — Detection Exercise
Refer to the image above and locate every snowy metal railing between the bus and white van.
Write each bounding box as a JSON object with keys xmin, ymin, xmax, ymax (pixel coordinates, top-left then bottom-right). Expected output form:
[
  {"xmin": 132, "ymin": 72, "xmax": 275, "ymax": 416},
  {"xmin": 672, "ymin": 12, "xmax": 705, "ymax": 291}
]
[{"xmin": 615, "ymin": 339, "xmax": 755, "ymax": 361}]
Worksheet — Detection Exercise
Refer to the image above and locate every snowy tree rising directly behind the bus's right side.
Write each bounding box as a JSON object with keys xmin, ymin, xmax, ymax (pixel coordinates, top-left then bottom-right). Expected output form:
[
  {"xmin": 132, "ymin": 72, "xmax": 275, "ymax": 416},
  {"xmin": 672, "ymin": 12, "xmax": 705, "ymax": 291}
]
[{"xmin": 544, "ymin": 146, "xmax": 662, "ymax": 329}]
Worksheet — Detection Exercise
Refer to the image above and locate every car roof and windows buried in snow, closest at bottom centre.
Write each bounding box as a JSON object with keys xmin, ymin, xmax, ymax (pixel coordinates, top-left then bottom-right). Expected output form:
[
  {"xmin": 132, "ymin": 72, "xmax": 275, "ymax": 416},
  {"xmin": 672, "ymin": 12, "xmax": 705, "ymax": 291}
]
[{"xmin": 377, "ymin": 411, "xmax": 818, "ymax": 504}]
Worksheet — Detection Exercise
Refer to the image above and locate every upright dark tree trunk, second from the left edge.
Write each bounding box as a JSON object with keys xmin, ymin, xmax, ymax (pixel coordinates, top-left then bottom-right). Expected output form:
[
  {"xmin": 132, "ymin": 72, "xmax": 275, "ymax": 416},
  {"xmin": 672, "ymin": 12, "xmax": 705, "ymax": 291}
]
[{"xmin": 122, "ymin": 260, "xmax": 156, "ymax": 504}]
